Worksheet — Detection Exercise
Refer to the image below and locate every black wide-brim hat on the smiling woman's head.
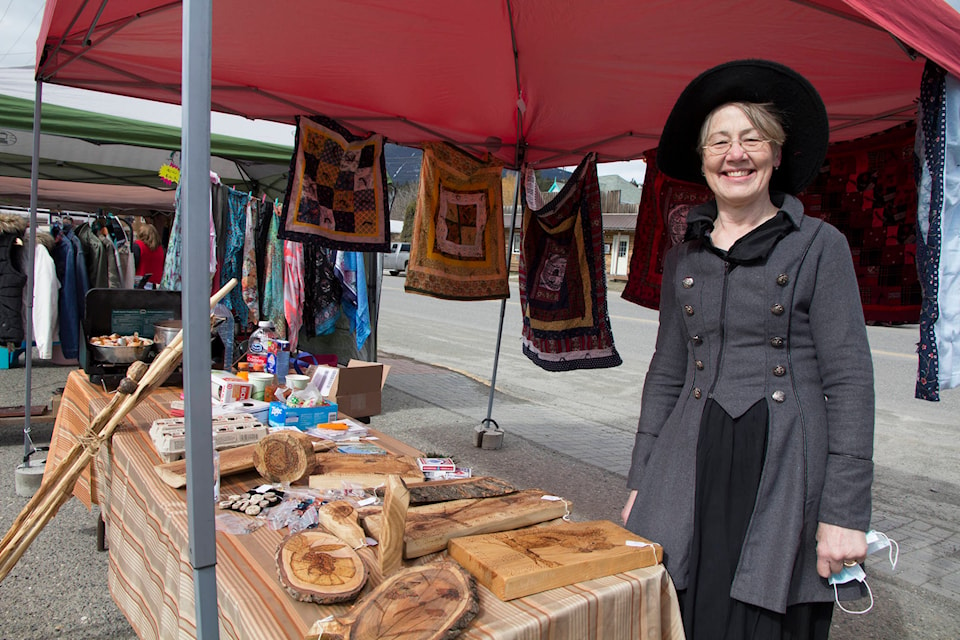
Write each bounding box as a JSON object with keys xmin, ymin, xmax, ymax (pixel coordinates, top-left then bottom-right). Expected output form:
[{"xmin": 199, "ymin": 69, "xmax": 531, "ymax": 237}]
[{"xmin": 657, "ymin": 60, "xmax": 830, "ymax": 195}]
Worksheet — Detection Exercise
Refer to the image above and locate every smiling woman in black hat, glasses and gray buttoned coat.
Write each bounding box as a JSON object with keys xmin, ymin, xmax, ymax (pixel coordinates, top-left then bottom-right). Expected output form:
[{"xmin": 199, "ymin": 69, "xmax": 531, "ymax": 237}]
[{"xmin": 622, "ymin": 60, "xmax": 874, "ymax": 640}]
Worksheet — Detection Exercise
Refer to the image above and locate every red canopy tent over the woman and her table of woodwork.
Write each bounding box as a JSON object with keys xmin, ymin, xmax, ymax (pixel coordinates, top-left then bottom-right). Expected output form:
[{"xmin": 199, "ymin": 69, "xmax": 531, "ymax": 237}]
[{"xmin": 26, "ymin": 0, "xmax": 960, "ymax": 636}]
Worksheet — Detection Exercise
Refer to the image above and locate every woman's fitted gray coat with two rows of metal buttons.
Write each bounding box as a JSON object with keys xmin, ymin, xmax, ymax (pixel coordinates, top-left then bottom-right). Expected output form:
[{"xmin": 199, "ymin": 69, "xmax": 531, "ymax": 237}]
[{"xmin": 627, "ymin": 195, "xmax": 874, "ymax": 613}]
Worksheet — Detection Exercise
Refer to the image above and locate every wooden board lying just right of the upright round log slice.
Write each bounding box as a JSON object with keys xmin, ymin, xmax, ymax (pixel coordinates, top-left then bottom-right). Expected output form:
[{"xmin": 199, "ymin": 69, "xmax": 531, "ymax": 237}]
[{"xmin": 310, "ymin": 453, "xmax": 423, "ymax": 489}]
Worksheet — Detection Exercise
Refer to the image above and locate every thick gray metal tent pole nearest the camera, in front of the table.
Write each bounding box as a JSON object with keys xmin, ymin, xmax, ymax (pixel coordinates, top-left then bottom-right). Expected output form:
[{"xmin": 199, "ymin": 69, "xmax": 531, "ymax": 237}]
[{"xmin": 180, "ymin": 0, "xmax": 220, "ymax": 639}]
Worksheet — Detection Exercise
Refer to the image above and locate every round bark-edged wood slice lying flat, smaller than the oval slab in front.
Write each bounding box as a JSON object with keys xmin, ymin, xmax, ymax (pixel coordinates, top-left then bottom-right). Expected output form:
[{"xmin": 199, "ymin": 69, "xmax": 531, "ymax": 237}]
[{"xmin": 277, "ymin": 529, "xmax": 376, "ymax": 604}]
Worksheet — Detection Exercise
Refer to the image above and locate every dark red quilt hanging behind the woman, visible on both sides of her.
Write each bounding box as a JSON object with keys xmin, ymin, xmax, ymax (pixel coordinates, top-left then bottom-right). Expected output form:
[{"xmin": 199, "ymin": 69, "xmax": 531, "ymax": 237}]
[{"xmin": 622, "ymin": 123, "xmax": 921, "ymax": 323}]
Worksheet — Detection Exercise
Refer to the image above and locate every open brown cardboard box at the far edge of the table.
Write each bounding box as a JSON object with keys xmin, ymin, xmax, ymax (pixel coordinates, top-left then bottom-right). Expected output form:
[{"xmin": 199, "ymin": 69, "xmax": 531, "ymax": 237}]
[{"xmin": 311, "ymin": 360, "xmax": 390, "ymax": 418}]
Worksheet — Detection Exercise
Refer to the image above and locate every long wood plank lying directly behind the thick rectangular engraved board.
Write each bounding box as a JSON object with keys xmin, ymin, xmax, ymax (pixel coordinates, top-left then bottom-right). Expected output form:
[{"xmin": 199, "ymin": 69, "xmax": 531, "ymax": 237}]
[{"xmin": 363, "ymin": 489, "xmax": 569, "ymax": 560}]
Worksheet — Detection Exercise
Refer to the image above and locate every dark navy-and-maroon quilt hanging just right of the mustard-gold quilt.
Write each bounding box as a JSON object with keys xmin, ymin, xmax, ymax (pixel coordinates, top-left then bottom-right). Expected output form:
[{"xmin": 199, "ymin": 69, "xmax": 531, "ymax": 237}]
[{"xmin": 520, "ymin": 153, "xmax": 622, "ymax": 371}]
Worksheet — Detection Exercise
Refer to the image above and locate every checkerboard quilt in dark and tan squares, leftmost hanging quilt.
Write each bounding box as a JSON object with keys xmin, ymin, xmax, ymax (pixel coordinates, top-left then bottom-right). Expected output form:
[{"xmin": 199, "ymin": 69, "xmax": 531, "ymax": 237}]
[{"xmin": 280, "ymin": 116, "xmax": 390, "ymax": 251}]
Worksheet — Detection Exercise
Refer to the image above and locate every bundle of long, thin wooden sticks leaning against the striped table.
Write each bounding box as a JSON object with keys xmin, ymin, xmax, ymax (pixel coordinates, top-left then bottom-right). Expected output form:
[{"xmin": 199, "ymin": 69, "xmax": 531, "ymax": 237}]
[{"xmin": 0, "ymin": 278, "xmax": 237, "ymax": 582}]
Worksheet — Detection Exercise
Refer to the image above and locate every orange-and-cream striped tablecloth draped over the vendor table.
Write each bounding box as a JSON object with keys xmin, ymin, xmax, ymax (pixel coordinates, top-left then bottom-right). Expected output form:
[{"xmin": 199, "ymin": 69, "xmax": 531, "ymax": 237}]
[{"xmin": 47, "ymin": 371, "xmax": 683, "ymax": 640}]
